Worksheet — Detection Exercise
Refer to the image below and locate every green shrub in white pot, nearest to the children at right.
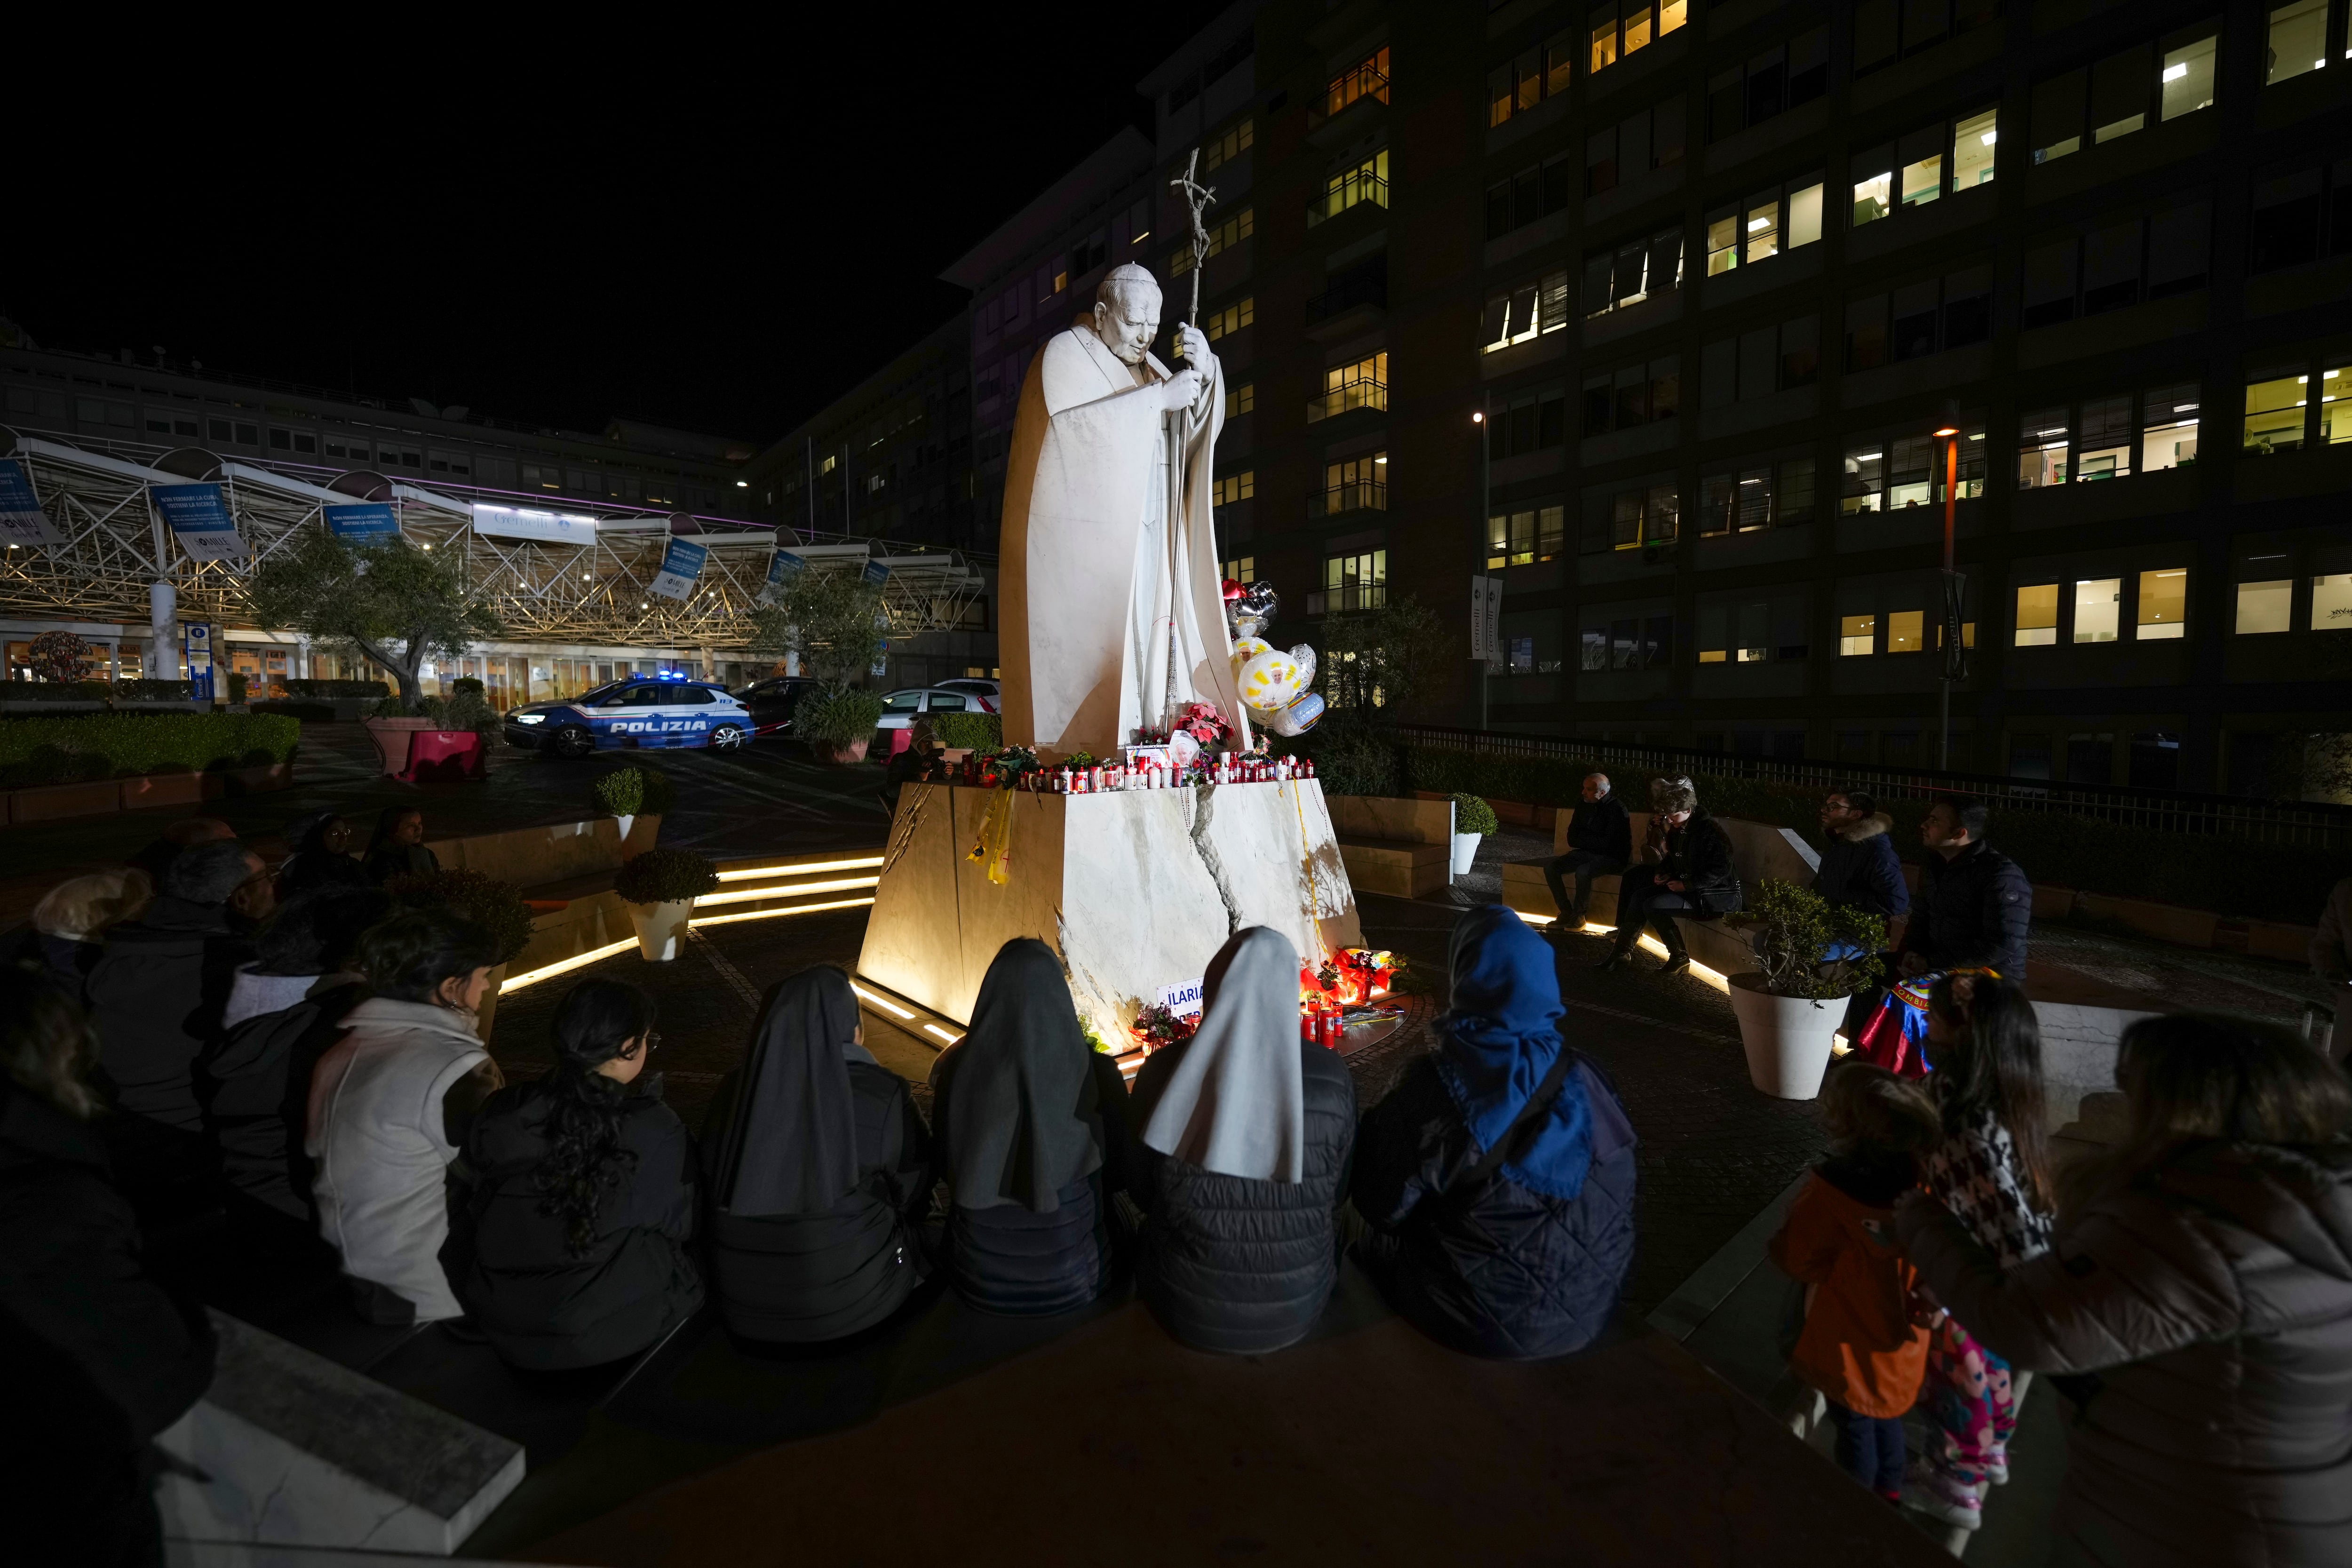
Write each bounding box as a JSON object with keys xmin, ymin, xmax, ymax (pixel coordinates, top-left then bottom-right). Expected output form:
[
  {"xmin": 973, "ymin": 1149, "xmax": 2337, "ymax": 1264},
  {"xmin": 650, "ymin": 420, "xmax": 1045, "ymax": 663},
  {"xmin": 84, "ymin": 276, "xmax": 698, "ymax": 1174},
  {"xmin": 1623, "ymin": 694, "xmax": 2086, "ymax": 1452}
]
[{"xmin": 1731, "ymin": 877, "xmax": 1886, "ymax": 1100}]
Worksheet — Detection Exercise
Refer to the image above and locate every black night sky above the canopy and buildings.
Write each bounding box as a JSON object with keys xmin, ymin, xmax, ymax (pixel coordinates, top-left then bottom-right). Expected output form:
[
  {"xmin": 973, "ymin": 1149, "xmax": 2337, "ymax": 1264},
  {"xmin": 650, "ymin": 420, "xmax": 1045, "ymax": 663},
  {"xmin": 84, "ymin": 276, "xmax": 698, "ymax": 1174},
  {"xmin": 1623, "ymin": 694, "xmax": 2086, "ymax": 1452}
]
[{"xmin": 18, "ymin": 5, "xmax": 1221, "ymax": 442}]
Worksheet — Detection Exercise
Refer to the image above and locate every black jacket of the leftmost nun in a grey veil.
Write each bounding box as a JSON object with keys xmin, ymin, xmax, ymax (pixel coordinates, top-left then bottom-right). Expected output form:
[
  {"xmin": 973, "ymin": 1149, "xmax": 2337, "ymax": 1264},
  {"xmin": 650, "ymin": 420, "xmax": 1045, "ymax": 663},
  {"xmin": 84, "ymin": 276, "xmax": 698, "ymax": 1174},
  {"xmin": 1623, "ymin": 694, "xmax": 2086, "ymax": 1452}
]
[{"xmin": 703, "ymin": 1063, "xmax": 931, "ymax": 1345}]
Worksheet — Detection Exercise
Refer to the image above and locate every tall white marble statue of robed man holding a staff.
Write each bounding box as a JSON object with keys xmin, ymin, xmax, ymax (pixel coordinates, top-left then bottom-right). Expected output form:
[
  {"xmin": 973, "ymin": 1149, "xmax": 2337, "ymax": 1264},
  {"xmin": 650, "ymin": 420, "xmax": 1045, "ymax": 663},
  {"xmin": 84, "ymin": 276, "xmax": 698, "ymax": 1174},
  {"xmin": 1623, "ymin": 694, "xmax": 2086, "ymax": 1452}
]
[{"xmin": 997, "ymin": 263, "xmax": 1249, "ymax": 759}]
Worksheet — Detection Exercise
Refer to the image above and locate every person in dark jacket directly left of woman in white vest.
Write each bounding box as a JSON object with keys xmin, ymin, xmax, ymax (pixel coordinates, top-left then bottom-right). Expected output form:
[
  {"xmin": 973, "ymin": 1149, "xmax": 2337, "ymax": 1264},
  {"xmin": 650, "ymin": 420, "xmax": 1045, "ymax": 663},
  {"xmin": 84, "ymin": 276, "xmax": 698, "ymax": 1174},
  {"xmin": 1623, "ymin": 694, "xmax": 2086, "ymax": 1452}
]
[{"xmin": 200, "ymin": 886, "xmax": 393, "ymax": 1222}]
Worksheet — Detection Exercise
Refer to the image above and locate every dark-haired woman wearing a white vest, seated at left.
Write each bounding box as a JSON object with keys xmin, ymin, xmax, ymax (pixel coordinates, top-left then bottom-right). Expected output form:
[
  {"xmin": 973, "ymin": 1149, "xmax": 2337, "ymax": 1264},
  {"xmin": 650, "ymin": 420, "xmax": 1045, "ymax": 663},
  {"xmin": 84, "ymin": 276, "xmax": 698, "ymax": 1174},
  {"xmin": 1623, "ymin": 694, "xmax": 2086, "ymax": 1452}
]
[{"xmin": 306, "ymin": 910, "xmax": 503, "ymax": 1323}]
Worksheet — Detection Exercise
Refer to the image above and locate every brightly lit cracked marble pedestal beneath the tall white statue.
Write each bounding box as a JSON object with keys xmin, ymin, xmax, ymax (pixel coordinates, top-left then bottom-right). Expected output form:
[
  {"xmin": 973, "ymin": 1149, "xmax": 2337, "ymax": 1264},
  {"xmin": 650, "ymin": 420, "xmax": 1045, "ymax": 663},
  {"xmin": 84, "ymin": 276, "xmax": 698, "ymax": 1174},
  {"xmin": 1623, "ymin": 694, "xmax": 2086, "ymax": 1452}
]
[{"xmin": 858, "ymin": 778, "xmax": 1364, "ymax": 1042}]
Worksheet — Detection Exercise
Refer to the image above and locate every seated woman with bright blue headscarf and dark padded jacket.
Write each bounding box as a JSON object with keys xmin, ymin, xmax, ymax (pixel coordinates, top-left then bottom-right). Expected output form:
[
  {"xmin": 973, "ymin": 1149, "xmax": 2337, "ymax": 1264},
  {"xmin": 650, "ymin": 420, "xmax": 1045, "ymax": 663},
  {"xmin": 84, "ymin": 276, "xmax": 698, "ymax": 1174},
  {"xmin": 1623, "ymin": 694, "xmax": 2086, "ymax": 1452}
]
[{"xmin": 1350, "ymin": 905, "xmax": 1635, "ymax": 1361}]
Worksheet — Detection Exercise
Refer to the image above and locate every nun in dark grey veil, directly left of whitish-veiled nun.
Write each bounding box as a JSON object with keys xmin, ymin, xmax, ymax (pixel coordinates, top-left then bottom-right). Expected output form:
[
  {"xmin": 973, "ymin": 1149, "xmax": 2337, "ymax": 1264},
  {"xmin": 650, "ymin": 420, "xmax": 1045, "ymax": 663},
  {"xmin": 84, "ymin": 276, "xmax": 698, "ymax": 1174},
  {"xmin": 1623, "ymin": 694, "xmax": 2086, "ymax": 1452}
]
[{"xmin": 931, "ymin": 936, "xmax": 1127, "ymax": 1314}]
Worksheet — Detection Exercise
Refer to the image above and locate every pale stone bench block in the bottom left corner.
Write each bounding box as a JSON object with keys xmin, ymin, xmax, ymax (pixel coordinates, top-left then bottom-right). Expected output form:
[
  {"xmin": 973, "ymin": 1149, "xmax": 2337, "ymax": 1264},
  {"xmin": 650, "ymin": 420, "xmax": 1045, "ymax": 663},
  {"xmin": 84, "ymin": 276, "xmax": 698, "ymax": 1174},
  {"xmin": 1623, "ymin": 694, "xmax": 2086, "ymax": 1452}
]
[{"xmin": 155, "ymin": 1312, "xmax": 522, "ymax": 1556}]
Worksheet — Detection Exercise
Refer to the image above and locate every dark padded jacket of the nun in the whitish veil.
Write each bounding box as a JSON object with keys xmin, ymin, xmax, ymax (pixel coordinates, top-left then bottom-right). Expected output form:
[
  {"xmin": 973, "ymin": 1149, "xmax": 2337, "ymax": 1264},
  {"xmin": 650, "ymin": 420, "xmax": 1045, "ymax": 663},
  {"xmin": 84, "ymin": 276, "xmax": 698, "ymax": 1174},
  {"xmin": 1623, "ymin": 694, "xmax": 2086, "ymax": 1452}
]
[{"xmin": 1129, "ymin": 1042, "xmax": 1355, "ymax": 1356}]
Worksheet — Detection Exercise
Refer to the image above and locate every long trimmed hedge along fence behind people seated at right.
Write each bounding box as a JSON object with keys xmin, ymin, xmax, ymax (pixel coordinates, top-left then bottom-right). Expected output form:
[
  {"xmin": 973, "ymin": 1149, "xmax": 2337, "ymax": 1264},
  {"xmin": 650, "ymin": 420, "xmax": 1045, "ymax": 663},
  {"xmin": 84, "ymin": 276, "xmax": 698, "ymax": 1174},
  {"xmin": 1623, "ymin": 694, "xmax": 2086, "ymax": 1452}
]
[{"xmin": 1399, "ymin": 745, "xmax": 2352, "ymax": 924}]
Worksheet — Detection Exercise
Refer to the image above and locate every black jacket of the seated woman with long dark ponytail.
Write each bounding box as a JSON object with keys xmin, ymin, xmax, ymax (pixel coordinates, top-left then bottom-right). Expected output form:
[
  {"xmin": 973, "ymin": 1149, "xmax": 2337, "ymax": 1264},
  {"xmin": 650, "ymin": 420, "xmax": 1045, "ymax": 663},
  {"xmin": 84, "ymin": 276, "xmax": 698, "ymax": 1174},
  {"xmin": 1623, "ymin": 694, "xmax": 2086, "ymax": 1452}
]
[{"xmin": 442, "ymin": 1084, "xmax": 703, "ymax": 1370}]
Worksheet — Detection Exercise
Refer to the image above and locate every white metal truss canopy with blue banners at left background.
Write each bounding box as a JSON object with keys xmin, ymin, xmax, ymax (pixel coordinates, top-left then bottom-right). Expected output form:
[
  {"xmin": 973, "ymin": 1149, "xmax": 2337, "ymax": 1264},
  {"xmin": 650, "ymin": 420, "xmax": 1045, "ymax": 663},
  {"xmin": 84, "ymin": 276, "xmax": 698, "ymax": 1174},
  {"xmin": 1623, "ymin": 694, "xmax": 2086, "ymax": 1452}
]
[{"xmin": 0, "ymin": 425, "xmax": 983, "ymax": 649}]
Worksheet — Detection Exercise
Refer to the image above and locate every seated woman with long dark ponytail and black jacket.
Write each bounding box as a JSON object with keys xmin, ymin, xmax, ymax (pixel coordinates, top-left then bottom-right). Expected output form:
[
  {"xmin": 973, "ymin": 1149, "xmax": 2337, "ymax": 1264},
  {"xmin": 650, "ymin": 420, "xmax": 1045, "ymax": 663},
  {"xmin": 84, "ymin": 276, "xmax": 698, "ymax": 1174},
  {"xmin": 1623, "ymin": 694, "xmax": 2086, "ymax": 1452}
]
[{"xmin": 449, "ymin": 980, "xmax": 703, "ymax": 1370}]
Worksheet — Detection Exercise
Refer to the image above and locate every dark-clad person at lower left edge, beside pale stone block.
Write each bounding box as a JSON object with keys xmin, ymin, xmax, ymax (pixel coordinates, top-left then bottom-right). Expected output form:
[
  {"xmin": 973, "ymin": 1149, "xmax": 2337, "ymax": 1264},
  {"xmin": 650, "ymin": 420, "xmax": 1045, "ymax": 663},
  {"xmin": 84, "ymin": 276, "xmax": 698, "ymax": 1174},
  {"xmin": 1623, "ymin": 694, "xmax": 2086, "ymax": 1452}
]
[{"xmin": 0, "ymin": 973, "xmax": 214, "ymax": 1563}]
